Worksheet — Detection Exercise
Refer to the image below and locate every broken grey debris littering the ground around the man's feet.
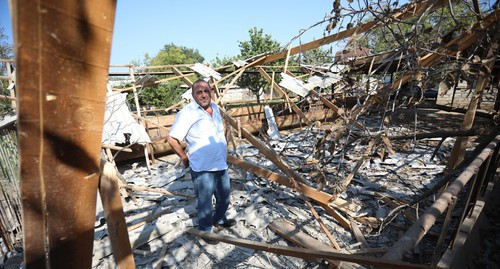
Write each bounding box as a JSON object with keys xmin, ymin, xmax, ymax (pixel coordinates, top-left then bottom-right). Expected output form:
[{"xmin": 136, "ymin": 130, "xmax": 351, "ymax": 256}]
[{"xmin": 93, "ymin": 108, "xmax": 492, "ymax": 268}]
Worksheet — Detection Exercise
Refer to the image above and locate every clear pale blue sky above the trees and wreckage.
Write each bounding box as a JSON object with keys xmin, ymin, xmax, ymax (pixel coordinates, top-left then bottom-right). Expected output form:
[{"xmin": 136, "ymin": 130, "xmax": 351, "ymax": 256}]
[{"xmin": 0, "ymin": 0, "xmax": 335, "ymax": 64}]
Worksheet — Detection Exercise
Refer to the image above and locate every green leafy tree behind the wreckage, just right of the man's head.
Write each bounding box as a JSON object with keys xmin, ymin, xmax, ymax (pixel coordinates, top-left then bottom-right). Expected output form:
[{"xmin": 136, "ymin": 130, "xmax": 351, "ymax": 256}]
[{"xmin": 234, "ymin": 27, "xmax": 284, "ymax": 101}]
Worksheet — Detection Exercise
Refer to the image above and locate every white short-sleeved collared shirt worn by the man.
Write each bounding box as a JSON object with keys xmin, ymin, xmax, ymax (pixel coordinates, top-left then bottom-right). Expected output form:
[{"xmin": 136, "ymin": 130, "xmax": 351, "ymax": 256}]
[{"xmin": 170, "ymin": 101, "xmax": 227, "ymax": 172}]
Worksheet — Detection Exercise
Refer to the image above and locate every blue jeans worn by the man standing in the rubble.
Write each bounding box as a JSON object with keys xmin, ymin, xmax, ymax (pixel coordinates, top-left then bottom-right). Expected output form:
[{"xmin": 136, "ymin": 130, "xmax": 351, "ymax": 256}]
[{"xmin": 191, "ymin": 169, "xmax": 230, "ymax": 232}]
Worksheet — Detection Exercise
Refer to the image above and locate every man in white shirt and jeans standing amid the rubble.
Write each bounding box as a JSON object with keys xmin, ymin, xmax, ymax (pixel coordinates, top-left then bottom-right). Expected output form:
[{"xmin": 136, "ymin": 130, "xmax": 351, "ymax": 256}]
[{"xmin": 166, "ymin": 79, "xmax": 236, "ymax": 240}]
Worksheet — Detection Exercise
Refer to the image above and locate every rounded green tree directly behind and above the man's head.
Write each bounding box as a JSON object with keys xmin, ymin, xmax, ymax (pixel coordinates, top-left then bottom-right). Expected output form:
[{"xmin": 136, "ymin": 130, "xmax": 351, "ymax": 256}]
[{"xmin": 133, "ymin": 43, "xmax": 204, "ymax": 108}]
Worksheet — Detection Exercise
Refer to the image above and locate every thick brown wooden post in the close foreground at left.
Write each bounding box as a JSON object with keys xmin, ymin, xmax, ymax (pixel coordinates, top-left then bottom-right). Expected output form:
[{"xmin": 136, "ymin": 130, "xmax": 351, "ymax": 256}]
[{"xmin": 12, "ymin": 0, "xmax": 116, "ymax": 269}]
